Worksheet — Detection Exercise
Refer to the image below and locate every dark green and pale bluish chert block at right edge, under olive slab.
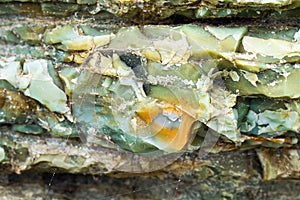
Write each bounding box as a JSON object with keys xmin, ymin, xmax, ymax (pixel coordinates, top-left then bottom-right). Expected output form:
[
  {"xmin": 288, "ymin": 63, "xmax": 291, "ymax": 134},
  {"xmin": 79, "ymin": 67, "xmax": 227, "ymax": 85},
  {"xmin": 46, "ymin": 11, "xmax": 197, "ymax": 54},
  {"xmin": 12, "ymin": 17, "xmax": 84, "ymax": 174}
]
[{"xmin": 238, "ymin": 97, "xmax": 300, "ymax": 137}]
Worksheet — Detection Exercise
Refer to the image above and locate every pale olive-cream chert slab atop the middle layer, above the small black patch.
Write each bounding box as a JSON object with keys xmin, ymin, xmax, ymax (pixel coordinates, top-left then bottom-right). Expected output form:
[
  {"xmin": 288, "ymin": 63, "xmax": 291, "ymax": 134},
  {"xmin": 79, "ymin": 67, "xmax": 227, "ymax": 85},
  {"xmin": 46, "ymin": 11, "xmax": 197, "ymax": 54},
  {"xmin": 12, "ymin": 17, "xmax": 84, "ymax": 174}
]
[{"xmin": 109, "ymin": 25, "xmax": 247, "ymax": 64}]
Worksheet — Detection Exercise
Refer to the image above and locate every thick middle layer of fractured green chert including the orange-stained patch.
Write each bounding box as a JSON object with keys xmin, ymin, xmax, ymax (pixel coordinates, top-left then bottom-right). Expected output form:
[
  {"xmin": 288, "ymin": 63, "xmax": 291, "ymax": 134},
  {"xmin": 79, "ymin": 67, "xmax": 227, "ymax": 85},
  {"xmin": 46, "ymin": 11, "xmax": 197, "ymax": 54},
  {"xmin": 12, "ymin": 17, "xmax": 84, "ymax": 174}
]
[{"xmin": 0, "ymin": 21, "xmax": 299, "ymax": 177}]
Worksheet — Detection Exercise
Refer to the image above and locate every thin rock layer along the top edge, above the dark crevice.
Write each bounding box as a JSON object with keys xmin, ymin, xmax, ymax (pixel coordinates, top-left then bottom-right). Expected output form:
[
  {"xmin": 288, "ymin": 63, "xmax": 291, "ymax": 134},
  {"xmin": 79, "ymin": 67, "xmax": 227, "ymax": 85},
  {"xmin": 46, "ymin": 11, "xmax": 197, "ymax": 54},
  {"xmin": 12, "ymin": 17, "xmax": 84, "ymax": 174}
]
[{"xmin": 0, "ymin": 0, "xmax": 300, "ymax": 22}]
